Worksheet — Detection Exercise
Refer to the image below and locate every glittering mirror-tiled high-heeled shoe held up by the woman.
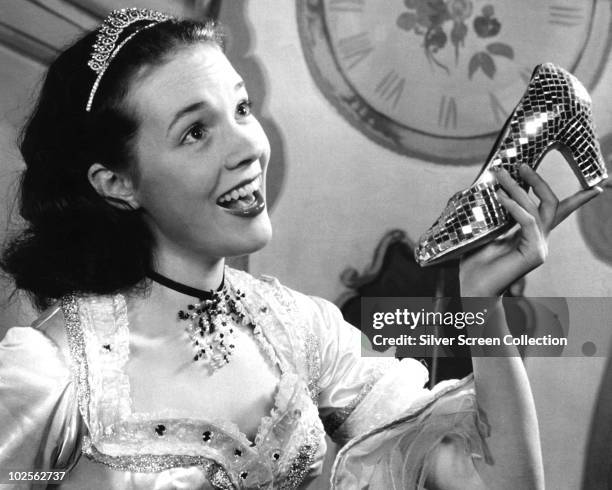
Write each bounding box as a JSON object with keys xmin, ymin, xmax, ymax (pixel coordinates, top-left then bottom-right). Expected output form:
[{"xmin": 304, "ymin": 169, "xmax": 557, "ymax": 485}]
[{"xmin": 415, "ymin": 63, "xmax": 608, "ymax": 266}]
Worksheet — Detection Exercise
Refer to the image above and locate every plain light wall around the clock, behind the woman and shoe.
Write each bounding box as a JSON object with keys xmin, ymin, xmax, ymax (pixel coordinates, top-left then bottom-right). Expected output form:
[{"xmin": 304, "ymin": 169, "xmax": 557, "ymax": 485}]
[{"xmin": 248, "ymin": 1, "xmax": 612, "ymax": 489}]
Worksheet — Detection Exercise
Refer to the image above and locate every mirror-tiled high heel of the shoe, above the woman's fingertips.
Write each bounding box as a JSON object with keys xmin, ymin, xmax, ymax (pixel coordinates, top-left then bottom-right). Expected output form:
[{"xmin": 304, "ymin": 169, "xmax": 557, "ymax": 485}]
[{"xmin": 557, "ymin": 111, "xmax": 608, "ymax": 189}]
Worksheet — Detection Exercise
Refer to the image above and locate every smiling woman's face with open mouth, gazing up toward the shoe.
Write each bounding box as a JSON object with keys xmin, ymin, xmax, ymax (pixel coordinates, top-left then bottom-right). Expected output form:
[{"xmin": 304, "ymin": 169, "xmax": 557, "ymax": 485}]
[{"xmin": 128, "ymin": 43, "xmax": 272, "ymax": 259}]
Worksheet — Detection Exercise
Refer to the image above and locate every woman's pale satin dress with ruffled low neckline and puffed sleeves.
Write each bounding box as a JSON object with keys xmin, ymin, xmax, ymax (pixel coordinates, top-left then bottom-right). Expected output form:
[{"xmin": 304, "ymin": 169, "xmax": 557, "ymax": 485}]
[{"xmin": 0, "ymin": 268, "xmax": 486, "ymax": 490}]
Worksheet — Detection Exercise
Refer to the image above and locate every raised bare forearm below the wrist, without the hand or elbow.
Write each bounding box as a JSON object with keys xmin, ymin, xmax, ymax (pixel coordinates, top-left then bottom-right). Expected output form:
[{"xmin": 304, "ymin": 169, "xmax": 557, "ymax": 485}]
[{"xmin": 470, "ymin": 298, "xmax": 544, "ymax": 489}]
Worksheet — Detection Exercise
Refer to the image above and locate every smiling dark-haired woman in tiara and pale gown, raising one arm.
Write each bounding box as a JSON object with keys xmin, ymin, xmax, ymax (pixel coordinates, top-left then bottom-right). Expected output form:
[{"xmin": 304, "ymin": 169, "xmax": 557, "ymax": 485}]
[{"xmin": 0, "ymin": 9, "xmax": 598, "ymax": 489}]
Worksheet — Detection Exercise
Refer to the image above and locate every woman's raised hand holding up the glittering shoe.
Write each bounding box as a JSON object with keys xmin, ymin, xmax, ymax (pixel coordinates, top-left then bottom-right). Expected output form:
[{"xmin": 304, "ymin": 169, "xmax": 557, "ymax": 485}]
[{"xmin": 459, "ymin": 164, "xmax": 603, "ymax": 297}]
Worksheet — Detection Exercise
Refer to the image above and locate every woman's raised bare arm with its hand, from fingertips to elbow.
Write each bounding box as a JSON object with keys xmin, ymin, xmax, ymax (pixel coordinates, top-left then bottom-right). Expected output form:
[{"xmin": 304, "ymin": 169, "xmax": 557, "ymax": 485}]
[{"xmin": 427, "ymin": 166, "xmax": 601, "ymax": 490}]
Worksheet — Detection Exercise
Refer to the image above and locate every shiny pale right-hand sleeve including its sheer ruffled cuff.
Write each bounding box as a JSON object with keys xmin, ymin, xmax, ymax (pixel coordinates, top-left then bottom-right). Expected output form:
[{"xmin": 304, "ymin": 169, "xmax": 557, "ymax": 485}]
[{"xmin": 304, "ymin": 298, "xmax": 490, "ymax": 490}]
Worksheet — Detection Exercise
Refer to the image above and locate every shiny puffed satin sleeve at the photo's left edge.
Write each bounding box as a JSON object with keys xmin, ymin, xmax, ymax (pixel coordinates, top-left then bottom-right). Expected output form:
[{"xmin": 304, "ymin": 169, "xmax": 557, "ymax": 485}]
[{"xmin": 0, "ymin": 327, "xmax": 81, "ymax": 488}]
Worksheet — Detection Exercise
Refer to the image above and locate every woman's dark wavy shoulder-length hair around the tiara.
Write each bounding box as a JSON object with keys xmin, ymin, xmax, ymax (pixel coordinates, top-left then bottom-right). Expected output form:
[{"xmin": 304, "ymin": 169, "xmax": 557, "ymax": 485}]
[{"xmin": 0, "ymin": 16, "xmax": 223, "ymax": 309}]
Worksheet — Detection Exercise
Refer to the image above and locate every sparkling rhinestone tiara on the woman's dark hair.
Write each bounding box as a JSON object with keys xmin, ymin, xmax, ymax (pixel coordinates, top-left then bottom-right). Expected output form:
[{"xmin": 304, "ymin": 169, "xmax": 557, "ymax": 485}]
[{"xmin": 85, "ymin": 8, "xmax": 174, "ymax": 112}]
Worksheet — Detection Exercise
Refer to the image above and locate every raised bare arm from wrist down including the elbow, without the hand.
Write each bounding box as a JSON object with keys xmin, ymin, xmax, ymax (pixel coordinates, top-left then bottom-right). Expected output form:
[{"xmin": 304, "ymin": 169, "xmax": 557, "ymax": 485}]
[{"xmin": 427, "ymin": 298, "xmax": 544, "ymax": 490}]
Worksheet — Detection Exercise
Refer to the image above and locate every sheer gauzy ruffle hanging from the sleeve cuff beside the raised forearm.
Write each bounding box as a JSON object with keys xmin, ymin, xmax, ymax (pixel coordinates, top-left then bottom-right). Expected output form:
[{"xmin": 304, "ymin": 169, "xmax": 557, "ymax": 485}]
[{"xmin": 330, "ymin": 376, "xmax": 491, "ymax": 489}]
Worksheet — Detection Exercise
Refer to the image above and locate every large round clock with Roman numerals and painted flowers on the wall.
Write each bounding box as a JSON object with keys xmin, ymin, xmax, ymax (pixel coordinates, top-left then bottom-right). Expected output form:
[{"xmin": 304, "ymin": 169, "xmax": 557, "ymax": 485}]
[{"xmin": 296, "ymin": 0, "xmax": 611, "ymax": 164}]
